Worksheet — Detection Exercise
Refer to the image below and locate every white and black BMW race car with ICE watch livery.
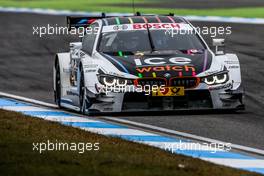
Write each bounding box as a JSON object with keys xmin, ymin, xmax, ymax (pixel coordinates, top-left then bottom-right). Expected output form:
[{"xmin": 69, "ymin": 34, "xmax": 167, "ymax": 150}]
[{"xmin": 53, "ymin": 14, "xmax": 244, "ymax": 114}]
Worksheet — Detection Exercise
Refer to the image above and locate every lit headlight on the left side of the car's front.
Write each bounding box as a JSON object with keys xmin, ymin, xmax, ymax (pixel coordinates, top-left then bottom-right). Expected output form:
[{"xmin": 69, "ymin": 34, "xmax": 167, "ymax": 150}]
[{"xmin": 99, "ymin": 75, "xmax": 134, "ymax": 87}]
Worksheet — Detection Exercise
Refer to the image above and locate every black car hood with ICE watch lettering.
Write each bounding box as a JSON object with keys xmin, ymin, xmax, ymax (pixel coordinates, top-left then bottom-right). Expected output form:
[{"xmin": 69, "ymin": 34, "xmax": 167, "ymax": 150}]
[{"xmin": 101, "ymin": 50, "xmax": 213, "ymax": 78}]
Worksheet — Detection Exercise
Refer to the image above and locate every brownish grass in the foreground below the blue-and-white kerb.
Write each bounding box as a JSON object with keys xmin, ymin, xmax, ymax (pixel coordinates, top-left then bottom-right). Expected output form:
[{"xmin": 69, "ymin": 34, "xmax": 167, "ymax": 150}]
[{"xmin": 0, "ymin": 110, "xmax": 257, "ymax": 176}]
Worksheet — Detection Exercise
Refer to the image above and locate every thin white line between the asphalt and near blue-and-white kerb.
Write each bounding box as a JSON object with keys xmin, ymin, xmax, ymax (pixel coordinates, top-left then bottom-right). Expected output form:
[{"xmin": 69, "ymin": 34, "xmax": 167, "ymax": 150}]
[{"xmin": 0, "ymin": 92, "xmax": 264, "ymax": 155}]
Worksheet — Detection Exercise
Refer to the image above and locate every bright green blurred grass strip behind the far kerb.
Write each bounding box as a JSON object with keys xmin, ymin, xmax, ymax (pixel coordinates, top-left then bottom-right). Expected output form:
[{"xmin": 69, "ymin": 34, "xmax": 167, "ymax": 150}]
[{"xmin": 0, "ymin": 0, "xmax": 264, "ymax": 18}]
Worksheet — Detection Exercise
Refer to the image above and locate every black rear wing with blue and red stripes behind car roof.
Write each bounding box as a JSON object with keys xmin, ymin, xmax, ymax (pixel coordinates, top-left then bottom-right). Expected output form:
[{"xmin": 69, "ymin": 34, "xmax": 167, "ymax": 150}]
[{"xmin": 67, "ymin": 12, "xmax": 174, "ymax": 31}]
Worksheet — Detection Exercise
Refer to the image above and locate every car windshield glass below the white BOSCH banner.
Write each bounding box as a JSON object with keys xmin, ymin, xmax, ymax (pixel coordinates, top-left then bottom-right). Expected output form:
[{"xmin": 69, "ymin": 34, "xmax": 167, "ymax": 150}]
[{"xmin": 99, "ymin": 26, "xmax": 205, "ymax": 53}]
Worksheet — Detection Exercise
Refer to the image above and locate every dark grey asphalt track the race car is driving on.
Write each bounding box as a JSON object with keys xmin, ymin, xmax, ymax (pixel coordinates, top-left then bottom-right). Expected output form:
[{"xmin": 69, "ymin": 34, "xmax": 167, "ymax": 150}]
[{"xmin": 0, "ymin": 13, "xmax": 264, "ymax": 149}]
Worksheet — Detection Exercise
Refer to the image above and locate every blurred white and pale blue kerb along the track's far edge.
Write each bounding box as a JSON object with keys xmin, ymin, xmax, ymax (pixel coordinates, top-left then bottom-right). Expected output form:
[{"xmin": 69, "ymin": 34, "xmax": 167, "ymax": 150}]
[{"xmin": 0, "ymin": 7, "xmax": 264, "ymax": 24}]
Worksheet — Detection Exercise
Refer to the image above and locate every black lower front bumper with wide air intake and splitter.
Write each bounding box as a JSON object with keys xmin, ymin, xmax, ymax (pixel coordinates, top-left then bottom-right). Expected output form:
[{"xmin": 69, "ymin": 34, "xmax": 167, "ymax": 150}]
[{"xmin": 89, "ymin": 83, "xmax": 244, "ymax": 112}]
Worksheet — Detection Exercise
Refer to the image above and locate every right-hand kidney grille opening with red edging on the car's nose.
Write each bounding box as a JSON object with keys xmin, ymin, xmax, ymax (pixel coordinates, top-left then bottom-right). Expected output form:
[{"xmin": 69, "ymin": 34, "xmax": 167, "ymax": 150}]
[{"xmin": 170, "ymin": 77, "xmax": 199, "ymax": 88}]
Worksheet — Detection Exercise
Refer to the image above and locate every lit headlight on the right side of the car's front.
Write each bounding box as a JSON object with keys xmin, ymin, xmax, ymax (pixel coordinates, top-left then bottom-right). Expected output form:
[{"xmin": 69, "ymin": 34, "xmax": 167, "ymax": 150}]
[{"xmin": 202, "ymin": 72, "xmax": 229, "ymax": 85}]
